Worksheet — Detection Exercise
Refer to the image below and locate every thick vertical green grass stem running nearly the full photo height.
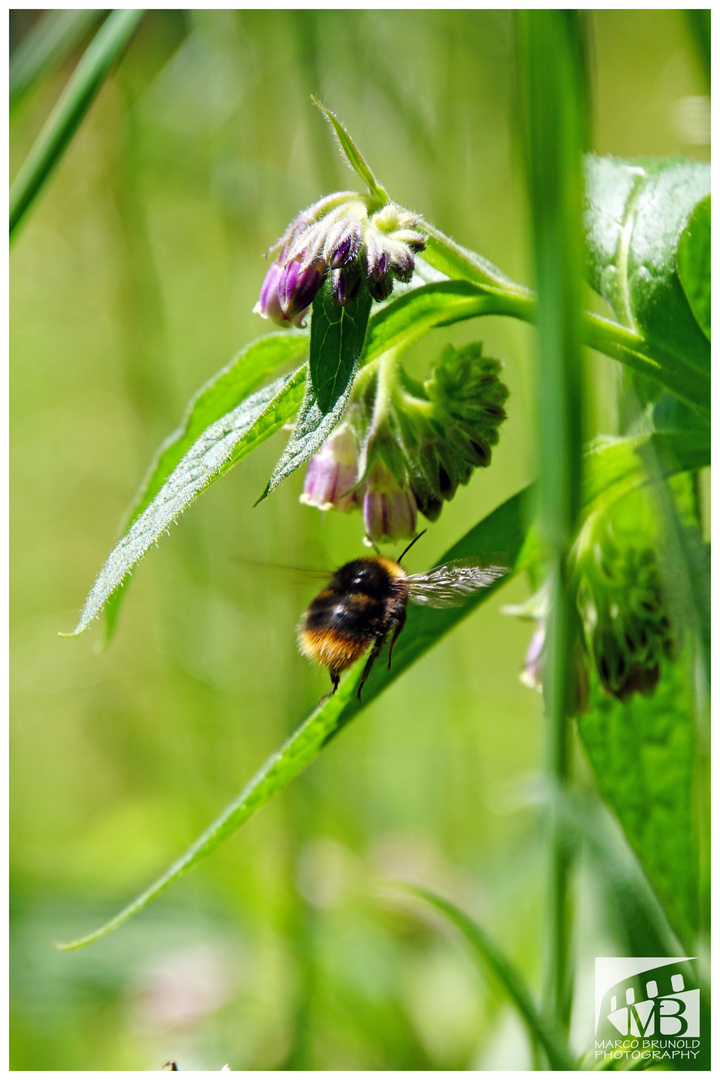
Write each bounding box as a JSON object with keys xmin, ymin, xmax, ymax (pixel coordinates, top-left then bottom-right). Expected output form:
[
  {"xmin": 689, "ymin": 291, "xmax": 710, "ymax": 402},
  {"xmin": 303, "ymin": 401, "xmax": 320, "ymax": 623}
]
[{"xmin": 518, "ymin": 10, "xmax": 587, "ymax": 1031}]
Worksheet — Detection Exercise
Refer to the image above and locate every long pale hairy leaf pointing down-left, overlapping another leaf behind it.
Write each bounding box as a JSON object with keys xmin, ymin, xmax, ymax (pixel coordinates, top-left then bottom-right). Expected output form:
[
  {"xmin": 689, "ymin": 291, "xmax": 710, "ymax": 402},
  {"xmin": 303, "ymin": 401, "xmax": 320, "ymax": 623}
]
[{"xmin": 68, "ymin": 366, "xmax": 307, "ymax": 636}]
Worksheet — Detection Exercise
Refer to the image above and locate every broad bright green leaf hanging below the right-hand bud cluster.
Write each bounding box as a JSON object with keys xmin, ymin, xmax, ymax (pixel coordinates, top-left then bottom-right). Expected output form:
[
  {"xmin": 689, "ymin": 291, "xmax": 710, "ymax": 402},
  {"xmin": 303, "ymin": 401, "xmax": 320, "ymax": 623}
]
[{"xmin": 578, "ymin": 657, "xmax": 697, "ymax": 948}]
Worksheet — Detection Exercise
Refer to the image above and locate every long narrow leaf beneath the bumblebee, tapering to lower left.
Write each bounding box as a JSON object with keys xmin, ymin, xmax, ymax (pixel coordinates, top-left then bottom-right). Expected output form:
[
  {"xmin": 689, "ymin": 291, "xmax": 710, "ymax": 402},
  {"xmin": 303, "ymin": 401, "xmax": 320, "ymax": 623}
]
[{"xmin": 57, "ymin": 491, "xmax": 528, "ymax": 949}]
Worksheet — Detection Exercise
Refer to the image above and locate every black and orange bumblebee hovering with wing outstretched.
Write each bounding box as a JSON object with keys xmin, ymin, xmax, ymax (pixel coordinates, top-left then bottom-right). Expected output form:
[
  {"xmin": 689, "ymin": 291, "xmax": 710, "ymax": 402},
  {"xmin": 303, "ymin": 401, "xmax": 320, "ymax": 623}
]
[{"xmin": 297, "ymin": 532, "xmax": 508, "ymax": 701}]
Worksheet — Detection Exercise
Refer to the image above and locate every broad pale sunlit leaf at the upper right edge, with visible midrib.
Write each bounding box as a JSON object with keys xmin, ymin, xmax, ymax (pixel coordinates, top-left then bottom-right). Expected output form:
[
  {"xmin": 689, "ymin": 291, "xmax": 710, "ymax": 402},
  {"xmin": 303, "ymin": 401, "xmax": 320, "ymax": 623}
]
[{"xmin": 585, "ymin": 154, "xmax": 710, "ymax": 373}]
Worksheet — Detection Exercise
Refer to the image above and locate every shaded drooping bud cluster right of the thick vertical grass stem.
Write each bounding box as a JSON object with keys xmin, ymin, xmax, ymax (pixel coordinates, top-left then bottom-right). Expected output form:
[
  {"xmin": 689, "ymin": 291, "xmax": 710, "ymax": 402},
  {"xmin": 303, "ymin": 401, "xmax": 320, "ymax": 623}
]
[{"xmin": 578, "ymin": 519, "xmax": 678, "ymax": 701}]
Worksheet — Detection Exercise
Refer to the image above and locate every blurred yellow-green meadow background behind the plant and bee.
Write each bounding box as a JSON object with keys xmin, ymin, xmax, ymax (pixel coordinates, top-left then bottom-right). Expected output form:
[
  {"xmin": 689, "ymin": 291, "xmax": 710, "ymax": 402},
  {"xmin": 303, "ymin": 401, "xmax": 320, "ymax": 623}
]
[{"xmin": 11, "ymin": 11, "xmax": 709, "ymax": 1070}]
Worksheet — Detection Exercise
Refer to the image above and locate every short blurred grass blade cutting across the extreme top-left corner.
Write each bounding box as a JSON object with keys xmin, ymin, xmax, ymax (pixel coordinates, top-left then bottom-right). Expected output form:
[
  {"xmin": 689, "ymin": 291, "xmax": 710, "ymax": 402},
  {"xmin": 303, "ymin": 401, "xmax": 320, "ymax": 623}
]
[{"xmin": 10, "ymin": 8, "xmax": 106, "ymax": 104}]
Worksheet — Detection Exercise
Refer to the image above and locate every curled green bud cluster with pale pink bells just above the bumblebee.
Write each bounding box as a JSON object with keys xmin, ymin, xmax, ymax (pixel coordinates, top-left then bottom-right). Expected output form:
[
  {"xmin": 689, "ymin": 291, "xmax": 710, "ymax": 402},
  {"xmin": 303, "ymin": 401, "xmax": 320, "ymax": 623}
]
[{"xmin": 301, "ymin": 345, "xmax": 507, "ymax": 543}]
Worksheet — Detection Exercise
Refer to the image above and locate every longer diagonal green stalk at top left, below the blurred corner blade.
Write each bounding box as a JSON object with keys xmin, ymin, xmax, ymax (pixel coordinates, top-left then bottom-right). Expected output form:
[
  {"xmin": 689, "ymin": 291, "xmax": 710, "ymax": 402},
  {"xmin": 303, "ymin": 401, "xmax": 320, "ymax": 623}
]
[{"xmin": 10, "ymin": 8, "xmax": 142, "ymax": 238}]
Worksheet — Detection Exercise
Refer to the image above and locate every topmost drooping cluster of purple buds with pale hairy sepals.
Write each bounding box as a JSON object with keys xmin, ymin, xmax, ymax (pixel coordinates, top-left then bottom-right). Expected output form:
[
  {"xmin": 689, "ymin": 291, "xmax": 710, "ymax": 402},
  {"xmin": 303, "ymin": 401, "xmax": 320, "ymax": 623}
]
[{"xmin": 254, "ymin": 191, "xmax": 425, "ymax": 326}]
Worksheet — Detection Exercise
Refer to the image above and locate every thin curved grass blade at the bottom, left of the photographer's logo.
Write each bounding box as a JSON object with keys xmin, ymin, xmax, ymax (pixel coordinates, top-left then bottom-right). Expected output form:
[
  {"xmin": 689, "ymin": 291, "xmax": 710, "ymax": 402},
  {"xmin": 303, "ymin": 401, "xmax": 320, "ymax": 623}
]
[{"xmin": 397, "ymin": 885, "xmax": 576, "ymax": 1071}]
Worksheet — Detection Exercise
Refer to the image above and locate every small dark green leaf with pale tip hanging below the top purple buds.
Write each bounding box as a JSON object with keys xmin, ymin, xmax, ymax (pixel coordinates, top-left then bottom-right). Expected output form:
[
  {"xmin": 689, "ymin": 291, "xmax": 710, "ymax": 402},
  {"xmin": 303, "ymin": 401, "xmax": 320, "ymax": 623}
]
[{"xmin": 258, "ymin": 276, "xmax": 372, "ymax": 502}]
